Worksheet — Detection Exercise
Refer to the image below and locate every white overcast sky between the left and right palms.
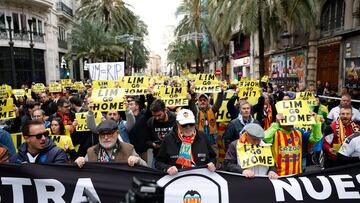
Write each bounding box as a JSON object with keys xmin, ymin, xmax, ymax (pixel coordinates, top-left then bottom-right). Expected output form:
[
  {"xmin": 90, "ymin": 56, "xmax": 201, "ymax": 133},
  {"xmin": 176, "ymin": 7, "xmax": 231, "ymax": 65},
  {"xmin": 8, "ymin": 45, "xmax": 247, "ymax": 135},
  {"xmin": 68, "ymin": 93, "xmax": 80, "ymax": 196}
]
[{"xmin": 125, "ymin": 0, "xmax": 181, "ymax": 61}]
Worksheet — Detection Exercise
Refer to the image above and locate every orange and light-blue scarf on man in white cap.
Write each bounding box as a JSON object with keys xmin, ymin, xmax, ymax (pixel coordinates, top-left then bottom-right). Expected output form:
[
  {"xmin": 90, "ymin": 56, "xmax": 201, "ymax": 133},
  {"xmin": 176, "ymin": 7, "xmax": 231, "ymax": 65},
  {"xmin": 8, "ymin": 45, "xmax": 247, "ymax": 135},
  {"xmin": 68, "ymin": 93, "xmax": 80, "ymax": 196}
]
[{"xmin": 176, "ymin": 128, "xmax": 196, "ymax": 168}]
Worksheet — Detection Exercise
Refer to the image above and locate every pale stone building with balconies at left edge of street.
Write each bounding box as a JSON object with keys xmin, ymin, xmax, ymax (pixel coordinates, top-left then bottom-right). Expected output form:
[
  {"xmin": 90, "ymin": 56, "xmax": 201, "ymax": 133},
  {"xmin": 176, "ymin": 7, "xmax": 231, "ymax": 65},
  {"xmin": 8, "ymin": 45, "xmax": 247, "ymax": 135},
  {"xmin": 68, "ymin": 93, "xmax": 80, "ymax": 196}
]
[{"xmin": 0, "ymin": 0, "xmax": 80, "ymax": 87}]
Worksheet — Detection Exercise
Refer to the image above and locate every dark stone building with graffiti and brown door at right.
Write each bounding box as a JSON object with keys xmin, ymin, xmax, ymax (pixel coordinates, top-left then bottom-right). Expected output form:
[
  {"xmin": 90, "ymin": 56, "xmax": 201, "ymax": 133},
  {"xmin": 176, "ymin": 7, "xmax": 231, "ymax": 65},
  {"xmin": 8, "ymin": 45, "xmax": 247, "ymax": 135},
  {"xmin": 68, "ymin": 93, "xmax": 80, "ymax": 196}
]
[{"xmin": 231, "ymin": 0, "xmax": 360, "ymax": 90}]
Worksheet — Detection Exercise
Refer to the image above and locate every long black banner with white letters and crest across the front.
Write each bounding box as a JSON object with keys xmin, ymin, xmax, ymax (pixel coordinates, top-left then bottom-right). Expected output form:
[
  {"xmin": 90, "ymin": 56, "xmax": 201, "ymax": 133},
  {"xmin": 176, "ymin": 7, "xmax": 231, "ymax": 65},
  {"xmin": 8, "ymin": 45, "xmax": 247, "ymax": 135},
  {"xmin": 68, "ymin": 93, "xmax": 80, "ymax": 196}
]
[{"xmin": 0, "ymin": 163, "xmax": 360, "ymax": 203}]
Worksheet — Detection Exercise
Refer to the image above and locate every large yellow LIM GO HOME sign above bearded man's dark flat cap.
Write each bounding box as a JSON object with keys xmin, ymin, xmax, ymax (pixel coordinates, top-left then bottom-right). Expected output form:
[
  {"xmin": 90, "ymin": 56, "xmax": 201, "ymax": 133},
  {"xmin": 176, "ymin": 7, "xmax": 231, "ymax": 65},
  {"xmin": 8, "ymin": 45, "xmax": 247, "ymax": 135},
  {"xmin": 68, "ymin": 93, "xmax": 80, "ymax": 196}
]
[{"xmin": 91, "ymin": 88, "xmax": 126, "ymax": 112}]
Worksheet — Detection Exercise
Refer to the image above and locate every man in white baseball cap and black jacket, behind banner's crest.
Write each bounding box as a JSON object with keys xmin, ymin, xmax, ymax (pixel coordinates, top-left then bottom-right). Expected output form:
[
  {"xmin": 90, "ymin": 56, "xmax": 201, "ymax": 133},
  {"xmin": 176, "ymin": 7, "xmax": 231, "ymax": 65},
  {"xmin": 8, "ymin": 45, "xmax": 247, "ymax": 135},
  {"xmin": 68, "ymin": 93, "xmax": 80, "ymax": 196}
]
[{"xmin": 155, "ymin": 109, "xmax": 216, "ymax": 175}]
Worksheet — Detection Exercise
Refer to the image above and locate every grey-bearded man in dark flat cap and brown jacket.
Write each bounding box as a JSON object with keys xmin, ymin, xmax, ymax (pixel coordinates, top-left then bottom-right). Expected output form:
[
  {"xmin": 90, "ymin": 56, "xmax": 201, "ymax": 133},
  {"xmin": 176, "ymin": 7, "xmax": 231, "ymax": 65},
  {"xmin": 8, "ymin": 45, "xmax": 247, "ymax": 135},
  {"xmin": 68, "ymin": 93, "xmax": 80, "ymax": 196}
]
[{"xmin": 75, "ymin": 119, "xmax": 147, "ymax": 168}]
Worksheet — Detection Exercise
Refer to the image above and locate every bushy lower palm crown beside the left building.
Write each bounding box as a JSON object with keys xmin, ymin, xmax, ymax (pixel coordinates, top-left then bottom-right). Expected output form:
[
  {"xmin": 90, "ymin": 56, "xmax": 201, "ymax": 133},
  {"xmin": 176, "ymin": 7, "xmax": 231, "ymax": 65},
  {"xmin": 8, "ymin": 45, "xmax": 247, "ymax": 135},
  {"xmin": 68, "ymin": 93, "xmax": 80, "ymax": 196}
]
[{"xmin": 67, "ymin": 20, "xmax": 124, "ymax": 62}]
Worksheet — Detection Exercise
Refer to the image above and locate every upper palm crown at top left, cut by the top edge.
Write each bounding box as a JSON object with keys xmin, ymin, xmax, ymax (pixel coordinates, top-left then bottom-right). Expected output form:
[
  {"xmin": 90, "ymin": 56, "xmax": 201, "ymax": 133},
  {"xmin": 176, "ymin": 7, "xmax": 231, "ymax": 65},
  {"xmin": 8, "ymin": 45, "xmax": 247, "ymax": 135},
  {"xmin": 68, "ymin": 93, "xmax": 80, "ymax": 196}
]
[{"xmin": 76, "ymin": 0, "xmax": 136, "ymax": 31}]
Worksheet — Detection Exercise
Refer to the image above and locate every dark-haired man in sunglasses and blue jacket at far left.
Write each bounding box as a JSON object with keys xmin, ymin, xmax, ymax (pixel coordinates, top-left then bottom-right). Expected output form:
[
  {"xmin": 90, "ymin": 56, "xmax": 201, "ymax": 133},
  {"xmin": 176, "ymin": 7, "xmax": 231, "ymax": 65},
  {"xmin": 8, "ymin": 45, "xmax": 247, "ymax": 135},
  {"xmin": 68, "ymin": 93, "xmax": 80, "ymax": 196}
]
[{"xmin": 10, "ymin": 120, "xmax": 68, "ymax": 164}]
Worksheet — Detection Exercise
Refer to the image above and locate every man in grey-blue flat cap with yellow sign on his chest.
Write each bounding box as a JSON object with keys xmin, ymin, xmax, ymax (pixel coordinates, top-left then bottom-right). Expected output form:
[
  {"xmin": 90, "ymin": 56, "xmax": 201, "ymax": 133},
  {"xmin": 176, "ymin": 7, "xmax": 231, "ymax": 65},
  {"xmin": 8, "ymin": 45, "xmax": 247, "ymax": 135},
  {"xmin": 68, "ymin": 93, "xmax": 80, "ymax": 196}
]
[{"xmin": 224, "ymin": 123, "xmax": 278, "ymax": 179}]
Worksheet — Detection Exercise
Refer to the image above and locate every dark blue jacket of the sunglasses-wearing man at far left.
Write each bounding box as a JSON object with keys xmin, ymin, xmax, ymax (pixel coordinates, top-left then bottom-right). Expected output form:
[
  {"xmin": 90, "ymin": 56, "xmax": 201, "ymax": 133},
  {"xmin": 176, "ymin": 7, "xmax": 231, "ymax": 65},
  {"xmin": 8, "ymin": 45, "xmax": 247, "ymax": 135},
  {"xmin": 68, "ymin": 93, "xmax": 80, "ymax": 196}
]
[{"xmin": 9, "ymin": 138, "xmax": 68, "ymax": 164}]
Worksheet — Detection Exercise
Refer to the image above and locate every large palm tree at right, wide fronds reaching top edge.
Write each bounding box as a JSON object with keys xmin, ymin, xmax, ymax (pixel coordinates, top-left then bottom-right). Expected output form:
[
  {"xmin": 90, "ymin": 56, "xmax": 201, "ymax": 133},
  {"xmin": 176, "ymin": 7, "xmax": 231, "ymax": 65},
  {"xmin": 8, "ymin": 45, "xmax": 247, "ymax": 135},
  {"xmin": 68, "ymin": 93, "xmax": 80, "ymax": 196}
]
[{"xmin": 207, "ymin": 0, "xmax": 316, "ymax": 77}]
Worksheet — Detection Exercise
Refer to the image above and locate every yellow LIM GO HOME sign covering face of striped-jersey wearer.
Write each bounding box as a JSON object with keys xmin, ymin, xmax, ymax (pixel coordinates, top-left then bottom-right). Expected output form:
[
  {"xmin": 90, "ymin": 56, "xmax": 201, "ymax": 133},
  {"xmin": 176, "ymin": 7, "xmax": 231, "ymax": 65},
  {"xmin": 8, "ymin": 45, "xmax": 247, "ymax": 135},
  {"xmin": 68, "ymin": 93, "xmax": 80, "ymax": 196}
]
[{"xmin": 275, "ymin": 100, "xmax": 315, "ymax": 125}]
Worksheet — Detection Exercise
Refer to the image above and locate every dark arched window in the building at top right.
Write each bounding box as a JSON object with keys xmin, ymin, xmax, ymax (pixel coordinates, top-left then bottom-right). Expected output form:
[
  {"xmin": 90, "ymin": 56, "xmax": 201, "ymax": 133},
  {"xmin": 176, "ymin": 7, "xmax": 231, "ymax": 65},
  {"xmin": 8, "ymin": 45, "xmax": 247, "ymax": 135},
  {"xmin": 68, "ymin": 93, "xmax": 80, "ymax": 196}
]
[{"xmin": 320, "ymin": 0, "xmax": 345, "ymax": 33}]
